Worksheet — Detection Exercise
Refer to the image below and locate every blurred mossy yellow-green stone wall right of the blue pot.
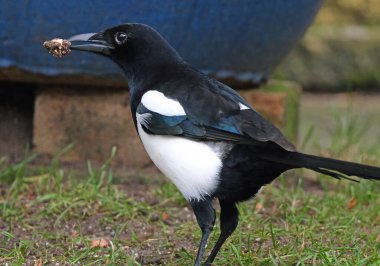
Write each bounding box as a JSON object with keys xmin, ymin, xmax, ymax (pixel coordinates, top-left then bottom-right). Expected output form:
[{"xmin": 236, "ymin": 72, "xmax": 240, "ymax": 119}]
[{"xmin": 274, "ymin": 0, "xmax": 380, "ymax": 92}]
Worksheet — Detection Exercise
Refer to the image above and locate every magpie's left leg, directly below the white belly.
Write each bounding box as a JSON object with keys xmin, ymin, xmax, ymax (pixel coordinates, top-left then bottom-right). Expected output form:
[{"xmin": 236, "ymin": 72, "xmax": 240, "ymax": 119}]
[{"xmin": 190, "ymin": 199, "xmax": 215, "ymax": 266}]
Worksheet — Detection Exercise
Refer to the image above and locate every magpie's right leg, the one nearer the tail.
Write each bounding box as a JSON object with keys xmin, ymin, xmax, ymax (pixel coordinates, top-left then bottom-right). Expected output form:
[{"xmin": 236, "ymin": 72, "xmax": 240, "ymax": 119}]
[{"xmin": 204, "ymin": 200, "xmax": 239, "ymax": 265}]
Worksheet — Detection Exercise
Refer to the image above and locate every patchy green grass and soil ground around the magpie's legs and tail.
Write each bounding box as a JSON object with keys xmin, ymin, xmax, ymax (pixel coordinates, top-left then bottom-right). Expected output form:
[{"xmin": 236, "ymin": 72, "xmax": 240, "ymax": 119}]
[{"xmin": 0, "ymin": 109, "xmax": 380, "ymax": 266}]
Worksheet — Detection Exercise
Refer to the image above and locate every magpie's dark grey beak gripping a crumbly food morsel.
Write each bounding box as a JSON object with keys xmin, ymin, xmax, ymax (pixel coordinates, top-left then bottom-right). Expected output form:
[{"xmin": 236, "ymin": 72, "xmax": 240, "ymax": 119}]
[{"xmin": 68, "ymin": 33, "xmax": 115, "ymax": 55}]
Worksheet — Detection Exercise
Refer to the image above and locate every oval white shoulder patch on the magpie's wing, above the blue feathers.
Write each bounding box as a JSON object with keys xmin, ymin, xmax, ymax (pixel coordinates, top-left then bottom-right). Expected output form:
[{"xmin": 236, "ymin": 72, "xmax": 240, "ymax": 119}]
[{"xmin": 141, "ymin": 90, "xmax": 186, "ymax": 116}]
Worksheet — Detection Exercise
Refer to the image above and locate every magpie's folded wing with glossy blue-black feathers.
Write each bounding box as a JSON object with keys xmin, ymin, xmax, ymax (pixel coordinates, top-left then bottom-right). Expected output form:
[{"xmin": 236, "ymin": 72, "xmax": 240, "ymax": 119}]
[{"xmin": 136, "ymin": 83, "xmax": 295, "ymax": 150}]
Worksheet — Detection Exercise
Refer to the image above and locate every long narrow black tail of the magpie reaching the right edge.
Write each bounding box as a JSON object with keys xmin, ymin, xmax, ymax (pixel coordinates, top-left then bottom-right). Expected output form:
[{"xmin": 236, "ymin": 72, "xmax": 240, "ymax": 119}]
[{"xmin": 264, "ymin": 151, "xmax": 380, "ymax": 180}]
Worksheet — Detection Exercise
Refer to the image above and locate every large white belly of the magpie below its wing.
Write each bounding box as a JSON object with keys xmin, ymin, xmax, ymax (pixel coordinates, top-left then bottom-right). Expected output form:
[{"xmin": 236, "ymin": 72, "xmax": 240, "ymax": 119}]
[{"xmin": 137, "ymin": 123, "xmax": 223, "ymax": 200}]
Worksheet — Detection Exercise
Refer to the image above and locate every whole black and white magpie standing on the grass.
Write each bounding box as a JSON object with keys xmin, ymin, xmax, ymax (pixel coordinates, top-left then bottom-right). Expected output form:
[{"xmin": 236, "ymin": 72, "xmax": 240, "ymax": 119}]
[{"xmin": 65, "ymin": 23, "xmax": 380, "ymax": 265}]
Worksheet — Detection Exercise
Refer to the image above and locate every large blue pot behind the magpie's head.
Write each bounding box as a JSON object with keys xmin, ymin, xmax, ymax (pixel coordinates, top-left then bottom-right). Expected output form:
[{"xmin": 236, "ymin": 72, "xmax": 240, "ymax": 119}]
[{"xmin": 0, "ymin": 0, "xmax": 322, "ymax": 83}]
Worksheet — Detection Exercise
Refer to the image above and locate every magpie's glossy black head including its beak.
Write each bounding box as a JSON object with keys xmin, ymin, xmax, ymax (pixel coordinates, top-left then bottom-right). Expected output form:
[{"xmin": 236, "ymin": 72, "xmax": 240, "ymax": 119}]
[{"xmin": 69, "ymin": 23, "xmax": 182, "ymax": 75}]
